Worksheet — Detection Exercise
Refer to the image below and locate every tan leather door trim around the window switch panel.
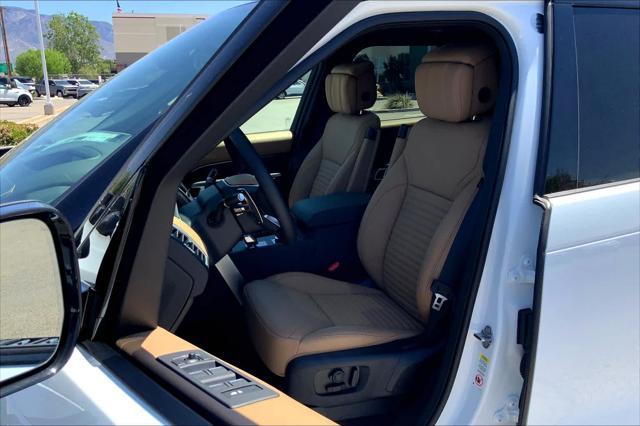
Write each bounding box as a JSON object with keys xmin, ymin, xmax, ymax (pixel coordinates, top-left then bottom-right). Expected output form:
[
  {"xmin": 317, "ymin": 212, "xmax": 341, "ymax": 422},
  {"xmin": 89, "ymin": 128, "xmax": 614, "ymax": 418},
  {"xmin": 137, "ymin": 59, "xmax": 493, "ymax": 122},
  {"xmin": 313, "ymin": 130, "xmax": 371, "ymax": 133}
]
[{"xmin": 116, "ymin": 327, "xmax": 336, "ymax": 425}]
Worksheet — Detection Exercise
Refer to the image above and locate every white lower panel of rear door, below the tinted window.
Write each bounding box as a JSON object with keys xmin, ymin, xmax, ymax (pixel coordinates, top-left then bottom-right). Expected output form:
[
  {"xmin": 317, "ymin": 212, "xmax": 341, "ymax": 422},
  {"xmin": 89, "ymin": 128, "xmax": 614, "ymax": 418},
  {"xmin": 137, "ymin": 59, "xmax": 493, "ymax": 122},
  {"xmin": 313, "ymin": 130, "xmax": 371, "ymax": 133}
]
[{"xmin": 526, "ymin": 181, "xmax": 640, "ymax": 424}]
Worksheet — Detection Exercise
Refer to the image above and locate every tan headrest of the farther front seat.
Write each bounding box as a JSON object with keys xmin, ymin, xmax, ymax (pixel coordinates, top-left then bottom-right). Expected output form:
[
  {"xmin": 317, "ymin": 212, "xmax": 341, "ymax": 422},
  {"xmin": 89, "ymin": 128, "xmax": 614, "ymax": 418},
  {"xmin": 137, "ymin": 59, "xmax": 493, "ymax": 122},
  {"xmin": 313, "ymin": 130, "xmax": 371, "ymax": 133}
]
[{"xmin": 324, "ymin": 61, "xmax": 376, "ymax": 114}]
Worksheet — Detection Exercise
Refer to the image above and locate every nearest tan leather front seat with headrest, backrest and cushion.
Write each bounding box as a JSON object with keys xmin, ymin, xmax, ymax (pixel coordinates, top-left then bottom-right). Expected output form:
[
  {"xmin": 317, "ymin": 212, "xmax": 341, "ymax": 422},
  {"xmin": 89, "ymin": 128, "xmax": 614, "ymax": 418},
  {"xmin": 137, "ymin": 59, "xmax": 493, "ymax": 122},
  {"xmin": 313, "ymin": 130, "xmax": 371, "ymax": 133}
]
[{"xmin": 244, "ymin": 45, "xmax": 497, "ymax": 376}]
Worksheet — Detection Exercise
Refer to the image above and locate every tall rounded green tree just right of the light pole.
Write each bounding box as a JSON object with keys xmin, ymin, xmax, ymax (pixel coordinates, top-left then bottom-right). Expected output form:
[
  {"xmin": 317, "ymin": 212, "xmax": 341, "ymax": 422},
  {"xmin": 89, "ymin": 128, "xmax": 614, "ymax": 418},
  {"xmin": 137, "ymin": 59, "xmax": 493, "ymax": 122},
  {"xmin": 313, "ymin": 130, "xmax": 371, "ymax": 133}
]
[{"xmin": 46, "ymin": 12, "xmax": 100, "ymax": 73}]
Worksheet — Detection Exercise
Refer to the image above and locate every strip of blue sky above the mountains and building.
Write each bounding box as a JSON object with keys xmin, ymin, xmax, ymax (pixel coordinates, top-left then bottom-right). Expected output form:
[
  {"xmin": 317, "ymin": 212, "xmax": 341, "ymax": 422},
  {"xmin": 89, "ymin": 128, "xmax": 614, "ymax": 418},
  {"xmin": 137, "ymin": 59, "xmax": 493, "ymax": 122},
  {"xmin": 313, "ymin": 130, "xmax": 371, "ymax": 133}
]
[{"xmin": 0, "ymin": 0, "xmax": 246, "ymax": 23}]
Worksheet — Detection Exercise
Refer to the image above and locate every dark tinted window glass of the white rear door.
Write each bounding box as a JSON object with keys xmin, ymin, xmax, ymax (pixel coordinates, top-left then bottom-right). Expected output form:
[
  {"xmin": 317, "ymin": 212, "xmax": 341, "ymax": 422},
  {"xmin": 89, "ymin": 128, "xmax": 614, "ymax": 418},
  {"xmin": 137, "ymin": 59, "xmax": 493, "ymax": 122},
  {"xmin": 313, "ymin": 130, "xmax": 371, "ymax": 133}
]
[{"xmin": 545, "ymin": 5, "xmax": 640, "ymax": 193}]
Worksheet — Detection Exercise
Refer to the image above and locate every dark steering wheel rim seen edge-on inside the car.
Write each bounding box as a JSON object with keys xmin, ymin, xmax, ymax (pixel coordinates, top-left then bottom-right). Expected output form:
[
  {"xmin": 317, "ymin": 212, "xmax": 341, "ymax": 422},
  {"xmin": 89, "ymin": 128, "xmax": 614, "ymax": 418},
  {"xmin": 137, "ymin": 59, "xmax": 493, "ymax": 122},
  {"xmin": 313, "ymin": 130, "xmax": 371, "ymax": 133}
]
[{"xmin": 227, "ymin": 128, "xmax": 296, "ymax": 243}]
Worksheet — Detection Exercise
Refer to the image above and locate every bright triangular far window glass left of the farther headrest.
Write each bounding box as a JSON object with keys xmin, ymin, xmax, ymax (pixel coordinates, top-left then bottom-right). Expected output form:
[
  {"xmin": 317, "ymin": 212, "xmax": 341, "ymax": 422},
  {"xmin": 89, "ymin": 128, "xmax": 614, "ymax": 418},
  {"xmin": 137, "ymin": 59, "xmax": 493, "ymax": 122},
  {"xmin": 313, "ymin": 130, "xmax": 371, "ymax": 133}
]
[{"xmin": 240, "ymin": 71, "xmax": 311, "ymax": 135}]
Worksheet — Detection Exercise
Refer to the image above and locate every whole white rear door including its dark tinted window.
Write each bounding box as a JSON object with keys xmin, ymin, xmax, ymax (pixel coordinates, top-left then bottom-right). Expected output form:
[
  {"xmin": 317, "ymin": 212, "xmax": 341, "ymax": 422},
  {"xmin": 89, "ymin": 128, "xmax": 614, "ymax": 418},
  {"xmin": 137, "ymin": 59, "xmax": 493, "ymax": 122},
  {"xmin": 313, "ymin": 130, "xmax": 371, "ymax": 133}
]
[{"xmin": 521, "ymin": 1, "xmax": 640, "ymax": 424}]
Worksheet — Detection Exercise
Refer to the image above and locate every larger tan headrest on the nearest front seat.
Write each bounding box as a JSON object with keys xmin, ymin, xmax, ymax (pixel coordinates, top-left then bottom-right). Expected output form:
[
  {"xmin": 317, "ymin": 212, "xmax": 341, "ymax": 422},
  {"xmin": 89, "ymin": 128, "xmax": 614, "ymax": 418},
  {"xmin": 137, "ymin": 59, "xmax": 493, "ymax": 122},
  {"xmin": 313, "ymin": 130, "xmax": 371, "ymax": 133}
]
[{"xmin": 416, "ymin": 44, "xmax": 498, "ymax": 123}]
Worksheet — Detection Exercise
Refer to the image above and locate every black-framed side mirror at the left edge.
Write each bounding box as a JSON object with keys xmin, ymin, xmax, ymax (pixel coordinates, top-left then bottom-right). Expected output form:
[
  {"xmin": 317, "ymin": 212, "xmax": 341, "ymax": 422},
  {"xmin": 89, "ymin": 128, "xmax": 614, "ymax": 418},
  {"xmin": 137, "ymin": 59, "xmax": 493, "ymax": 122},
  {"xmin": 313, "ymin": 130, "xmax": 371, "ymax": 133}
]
[{"xmin": 0, "ymin": 201, "xmax": 81, "ymax": 398}]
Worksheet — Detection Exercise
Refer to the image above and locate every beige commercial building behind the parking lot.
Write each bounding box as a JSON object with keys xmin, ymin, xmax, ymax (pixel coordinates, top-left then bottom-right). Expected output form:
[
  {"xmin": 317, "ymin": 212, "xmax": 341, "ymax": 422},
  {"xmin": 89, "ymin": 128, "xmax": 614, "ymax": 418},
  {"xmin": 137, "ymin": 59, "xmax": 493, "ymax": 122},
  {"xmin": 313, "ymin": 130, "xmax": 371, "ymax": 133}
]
[{"xmin": 111, "ymin": 12, "xmax": 207, "ymax": 71}]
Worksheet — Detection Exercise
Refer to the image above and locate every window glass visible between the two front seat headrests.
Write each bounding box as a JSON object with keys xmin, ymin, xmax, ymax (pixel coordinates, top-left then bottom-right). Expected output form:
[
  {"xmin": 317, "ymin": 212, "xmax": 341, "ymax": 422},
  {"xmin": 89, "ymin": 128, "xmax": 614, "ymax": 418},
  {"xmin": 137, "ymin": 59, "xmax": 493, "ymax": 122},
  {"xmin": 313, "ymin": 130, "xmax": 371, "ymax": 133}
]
[{"xmin": 354, "ymin": 46, "xmax": 432, "ymax": 122}]
